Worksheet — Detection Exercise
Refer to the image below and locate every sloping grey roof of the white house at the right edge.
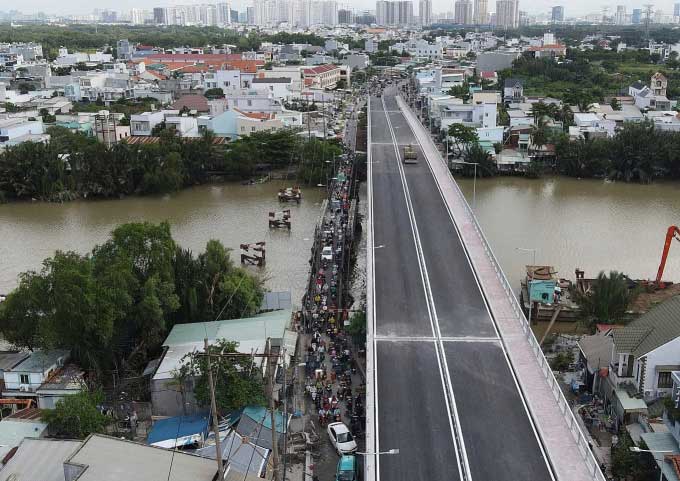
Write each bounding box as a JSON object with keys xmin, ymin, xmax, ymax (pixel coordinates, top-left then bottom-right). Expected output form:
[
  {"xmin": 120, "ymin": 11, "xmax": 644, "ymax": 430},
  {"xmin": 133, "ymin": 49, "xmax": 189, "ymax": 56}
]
[{"xmin": 613, "ymin": 296, "xmax": 680, "ymax": 357}]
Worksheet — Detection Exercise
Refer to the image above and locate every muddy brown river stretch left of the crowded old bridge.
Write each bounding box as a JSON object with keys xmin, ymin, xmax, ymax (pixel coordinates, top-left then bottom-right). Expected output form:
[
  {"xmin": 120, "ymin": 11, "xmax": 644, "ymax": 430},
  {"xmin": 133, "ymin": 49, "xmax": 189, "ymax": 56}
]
[{"xmin": 0, "ymin": 182, "xmax": 325, "ymax": 305}]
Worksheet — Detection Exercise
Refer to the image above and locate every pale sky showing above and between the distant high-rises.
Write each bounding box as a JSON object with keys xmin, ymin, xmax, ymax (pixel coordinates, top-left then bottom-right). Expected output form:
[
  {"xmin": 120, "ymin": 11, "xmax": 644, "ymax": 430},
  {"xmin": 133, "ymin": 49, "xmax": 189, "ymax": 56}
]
[{"xmin": 6, "ymin": 0, "xmax": 676, "ymax": 18}]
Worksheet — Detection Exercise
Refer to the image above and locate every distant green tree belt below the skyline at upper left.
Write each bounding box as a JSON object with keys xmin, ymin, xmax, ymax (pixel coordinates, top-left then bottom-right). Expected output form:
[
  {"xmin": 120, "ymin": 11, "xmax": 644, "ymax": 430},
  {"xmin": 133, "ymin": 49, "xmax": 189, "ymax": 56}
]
[{"xmin": 0, "ymin": 24, "xmax": 325, "ymax": 59}]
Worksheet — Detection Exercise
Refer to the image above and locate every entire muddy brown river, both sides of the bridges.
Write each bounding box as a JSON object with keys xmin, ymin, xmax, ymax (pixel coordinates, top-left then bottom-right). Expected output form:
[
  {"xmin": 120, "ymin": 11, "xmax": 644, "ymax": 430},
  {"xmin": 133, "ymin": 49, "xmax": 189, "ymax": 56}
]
[{"xmin": 0, "ymin": 177, "xmax": 680, "ymax": 302}]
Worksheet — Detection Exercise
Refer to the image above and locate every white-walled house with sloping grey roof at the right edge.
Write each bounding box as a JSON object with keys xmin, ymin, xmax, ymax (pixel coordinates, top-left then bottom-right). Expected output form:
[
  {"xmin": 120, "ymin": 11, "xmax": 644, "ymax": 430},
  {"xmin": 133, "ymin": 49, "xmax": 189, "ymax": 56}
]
[{"xmin": 605, "ymin": 296, "xmax": 680, "ymax": 422}]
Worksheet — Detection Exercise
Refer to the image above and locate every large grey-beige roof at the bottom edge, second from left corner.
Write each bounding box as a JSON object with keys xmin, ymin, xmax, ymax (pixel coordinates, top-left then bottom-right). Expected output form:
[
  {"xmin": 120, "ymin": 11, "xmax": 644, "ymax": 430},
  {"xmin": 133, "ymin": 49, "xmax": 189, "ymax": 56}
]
[{"xmin": 62, "ymin": 434, "xmax": 217, "ymax": 481}]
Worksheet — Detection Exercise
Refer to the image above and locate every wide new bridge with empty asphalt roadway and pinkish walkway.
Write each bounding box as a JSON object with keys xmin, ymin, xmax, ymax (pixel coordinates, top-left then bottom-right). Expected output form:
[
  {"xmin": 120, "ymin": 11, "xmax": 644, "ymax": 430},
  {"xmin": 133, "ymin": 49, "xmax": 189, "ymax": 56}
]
[{"xmin": 365, "ymin": 89, "xmax": 604, "ymax": 481}]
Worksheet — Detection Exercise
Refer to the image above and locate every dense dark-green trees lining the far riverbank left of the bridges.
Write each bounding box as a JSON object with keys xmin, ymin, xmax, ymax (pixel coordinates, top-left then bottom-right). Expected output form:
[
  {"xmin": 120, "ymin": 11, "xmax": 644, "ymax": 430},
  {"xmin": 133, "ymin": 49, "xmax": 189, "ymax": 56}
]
[{"xmin": 0, "ymin": 127, "xmax": 342, "ymax": 202}]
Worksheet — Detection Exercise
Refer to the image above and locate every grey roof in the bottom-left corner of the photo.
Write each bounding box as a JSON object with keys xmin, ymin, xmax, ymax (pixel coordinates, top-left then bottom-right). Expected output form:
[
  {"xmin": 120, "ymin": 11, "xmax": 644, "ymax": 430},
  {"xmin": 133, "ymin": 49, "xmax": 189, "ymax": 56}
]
[{"xmin": 0, "ymin": 438, "xmax": 81, "ymax": 481}]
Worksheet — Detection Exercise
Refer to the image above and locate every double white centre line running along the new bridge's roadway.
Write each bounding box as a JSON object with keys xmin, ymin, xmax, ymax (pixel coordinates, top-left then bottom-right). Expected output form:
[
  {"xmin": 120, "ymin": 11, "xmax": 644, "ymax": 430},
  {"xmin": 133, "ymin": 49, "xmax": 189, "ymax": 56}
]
[{"xmin": 382, "ymin": 97, "xmax": 472, "ymax": 481}]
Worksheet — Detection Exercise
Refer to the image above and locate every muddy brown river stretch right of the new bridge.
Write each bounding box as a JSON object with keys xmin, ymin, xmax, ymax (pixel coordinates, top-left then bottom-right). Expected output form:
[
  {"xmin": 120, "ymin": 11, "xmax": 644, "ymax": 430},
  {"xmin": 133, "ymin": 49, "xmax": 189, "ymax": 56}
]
[{"xmin": 457, "ymin": 177, "xmax": 680, "ymax": 287}]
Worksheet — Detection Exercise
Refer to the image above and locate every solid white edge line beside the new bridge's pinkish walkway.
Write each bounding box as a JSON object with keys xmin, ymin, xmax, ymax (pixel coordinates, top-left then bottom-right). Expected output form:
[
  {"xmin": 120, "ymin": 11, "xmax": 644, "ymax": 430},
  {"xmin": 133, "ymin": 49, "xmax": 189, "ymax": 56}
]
[{"xmin": 397, "ymin": 94, "xmax": 556, "ymax": 480}]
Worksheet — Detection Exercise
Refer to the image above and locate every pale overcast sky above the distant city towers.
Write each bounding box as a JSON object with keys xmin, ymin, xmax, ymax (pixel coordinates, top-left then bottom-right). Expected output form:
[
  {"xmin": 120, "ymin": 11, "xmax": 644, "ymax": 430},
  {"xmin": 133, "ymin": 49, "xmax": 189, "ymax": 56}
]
[{"xmin": 9, "ymin": 0, "xmax": 674, "ymax": 17}]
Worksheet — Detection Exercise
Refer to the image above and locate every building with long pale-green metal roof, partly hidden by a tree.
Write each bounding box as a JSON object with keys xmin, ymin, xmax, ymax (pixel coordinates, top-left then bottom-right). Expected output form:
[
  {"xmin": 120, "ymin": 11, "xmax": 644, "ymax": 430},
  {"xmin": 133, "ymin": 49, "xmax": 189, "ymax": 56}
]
[{"xmin": 150, "ymin": 309, "xmax": 294, "ymax": 416}]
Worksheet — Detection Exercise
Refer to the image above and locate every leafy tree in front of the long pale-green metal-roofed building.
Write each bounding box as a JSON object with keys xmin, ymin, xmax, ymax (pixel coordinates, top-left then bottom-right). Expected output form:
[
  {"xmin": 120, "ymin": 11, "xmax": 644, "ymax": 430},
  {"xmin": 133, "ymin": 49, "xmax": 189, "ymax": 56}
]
[{"xmin": 174, "ymin": 339, "xmax": 266, "ymax": 415}]
